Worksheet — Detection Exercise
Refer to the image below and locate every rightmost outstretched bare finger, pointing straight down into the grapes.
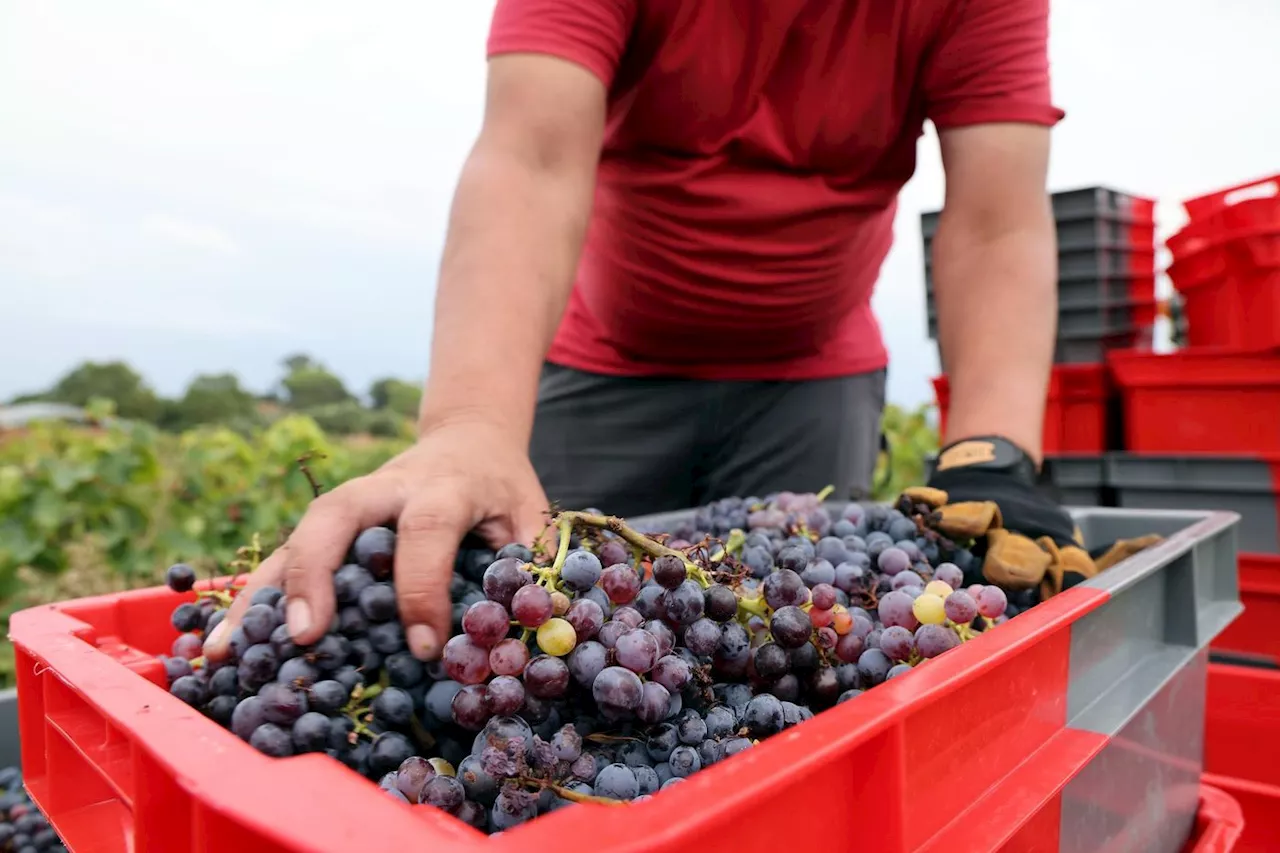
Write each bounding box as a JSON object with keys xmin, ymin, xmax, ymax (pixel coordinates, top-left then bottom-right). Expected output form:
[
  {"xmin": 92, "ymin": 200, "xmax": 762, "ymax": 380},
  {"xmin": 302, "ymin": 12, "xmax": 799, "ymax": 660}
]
[{"xmin": 396, "ymin": 487, "xmax": 479, "ymax": 661}]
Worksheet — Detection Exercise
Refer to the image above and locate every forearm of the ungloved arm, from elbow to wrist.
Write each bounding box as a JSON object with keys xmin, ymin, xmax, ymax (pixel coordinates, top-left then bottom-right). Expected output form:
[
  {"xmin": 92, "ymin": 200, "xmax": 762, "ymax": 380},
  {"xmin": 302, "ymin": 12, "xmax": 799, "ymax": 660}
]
[{"xmin": 420, "ymin": 142, "xmax": 594, "ymax": 442}]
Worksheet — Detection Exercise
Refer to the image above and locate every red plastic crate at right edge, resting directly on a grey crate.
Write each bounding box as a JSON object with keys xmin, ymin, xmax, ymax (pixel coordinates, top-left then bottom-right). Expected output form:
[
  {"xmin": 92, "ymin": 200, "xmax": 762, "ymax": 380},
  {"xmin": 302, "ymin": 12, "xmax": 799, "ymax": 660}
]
[{"xmin": 1107, "ymin": 350, "xmax": 1280, "ymax": 455}]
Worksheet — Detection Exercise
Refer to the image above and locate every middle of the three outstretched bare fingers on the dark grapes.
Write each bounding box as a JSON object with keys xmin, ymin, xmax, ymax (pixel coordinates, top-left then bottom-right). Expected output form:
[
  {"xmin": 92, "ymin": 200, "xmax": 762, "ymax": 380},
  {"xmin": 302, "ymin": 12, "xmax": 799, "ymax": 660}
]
[{"xmin": 284, "ymin": 474, "xmax": 404, "ymax": 646}]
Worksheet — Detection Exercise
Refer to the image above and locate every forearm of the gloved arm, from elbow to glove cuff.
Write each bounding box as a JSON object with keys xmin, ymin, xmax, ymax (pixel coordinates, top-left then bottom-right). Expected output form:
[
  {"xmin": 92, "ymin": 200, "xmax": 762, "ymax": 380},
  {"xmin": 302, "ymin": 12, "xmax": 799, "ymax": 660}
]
[{"xmin": 933, "ymin": 211, "xmax": 1057, "ymax": 462}]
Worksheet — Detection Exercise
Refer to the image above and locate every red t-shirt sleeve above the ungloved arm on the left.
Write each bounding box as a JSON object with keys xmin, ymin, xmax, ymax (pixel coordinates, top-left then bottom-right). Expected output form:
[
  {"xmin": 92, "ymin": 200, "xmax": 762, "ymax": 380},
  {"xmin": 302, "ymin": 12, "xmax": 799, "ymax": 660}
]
[{"xmin": 488, "ymin": 0, "xmax": 636, "ymax": 88}]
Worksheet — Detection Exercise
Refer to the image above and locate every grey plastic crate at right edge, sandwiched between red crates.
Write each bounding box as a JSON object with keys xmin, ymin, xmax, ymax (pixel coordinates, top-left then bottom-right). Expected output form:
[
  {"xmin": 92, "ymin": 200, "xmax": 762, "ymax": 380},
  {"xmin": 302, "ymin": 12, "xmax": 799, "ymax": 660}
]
[{"xmin": 1107, "ymin": 453, "xmax": 1280, "ymax": 553}]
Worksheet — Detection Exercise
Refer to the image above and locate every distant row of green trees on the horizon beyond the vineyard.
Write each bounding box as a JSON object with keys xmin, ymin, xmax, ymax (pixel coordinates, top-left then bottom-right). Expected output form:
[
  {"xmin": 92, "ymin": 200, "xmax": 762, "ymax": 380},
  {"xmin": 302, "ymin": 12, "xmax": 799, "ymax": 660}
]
[{"xmin": 10, "ymin": 353, "xmax": 422, "ymax": 437}]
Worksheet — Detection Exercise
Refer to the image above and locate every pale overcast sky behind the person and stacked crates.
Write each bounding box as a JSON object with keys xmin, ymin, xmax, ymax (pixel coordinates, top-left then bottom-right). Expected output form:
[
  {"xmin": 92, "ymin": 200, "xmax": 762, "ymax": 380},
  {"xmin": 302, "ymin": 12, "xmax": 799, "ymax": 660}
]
[{"xmin": 0, "ymin": 0, "xmax": 1280, "ymax": 405}]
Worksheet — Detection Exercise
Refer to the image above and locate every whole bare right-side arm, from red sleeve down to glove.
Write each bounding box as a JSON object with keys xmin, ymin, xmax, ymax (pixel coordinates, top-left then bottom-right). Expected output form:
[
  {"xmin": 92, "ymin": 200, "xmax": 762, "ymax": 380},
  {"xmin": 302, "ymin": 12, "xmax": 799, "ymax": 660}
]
[{"xmin": 933, "ymin": 123, "xmax": 1057, "ymax": 462}]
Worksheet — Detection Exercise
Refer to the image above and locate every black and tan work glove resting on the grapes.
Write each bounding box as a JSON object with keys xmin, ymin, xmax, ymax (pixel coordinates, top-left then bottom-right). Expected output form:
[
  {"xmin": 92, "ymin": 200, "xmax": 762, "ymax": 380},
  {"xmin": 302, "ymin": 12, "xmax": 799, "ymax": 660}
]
[{"xmin": 902, "ymin": 437, "xmax": 1160, "ymax": 601}]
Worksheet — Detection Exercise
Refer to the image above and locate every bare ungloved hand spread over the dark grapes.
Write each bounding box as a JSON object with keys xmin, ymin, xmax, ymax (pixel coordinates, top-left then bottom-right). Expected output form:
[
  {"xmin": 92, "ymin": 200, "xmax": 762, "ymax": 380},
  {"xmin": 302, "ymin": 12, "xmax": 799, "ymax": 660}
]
[{"xmin": 205, "ymin": 421, "xmax": 548, "ymax": 660}]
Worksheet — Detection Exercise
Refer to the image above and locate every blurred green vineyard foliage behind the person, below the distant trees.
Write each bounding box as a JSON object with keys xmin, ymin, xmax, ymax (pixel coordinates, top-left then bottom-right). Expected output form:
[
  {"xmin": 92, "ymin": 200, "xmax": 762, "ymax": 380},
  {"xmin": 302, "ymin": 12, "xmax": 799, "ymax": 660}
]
[{"xmin": 0, "ymin": 406, "xmax": 937, "ymax": 685}]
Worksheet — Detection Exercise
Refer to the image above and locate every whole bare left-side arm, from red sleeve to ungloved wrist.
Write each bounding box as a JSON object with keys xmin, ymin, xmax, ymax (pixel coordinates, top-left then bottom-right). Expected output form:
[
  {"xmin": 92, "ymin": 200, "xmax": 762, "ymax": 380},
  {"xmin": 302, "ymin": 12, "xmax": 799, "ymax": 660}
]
[{"xmin": 420, "ymin": 54, "xmax": 605, "ymax": 446}]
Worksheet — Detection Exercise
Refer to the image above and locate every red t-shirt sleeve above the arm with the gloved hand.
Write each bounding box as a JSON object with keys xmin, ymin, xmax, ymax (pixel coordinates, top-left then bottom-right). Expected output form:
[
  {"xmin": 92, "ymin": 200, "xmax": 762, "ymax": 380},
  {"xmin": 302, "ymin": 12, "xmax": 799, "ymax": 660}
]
[{"xmin": 924, "ymin": 0, "xmax": 1065, "ymax": 129}]
